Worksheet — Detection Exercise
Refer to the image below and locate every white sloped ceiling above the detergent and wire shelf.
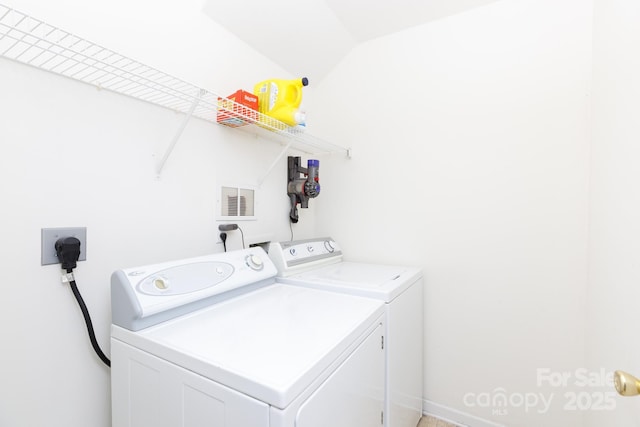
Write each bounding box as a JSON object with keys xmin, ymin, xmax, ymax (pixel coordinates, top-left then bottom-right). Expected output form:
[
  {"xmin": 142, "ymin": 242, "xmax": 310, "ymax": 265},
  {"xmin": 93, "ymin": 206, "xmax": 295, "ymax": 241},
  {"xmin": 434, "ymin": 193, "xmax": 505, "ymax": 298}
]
[{"xmin": 203, "ymin": 0, "xmax": 498, "ymax": 82}]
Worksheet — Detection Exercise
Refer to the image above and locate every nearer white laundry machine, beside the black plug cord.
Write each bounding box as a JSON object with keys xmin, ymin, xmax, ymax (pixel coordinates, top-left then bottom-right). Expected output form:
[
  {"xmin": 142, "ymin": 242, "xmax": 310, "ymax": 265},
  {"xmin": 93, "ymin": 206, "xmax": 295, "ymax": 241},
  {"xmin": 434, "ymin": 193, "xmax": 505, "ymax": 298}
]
[{"xmin": 111, "ymin": 248, "xmax": 384, "ymax": 427}]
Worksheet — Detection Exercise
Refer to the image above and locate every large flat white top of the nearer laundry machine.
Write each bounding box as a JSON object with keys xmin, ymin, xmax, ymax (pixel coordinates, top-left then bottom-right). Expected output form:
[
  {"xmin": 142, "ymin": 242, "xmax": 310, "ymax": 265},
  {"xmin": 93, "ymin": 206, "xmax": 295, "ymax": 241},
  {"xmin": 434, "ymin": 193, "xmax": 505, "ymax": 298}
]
[{"xmin": 112, "ymin": 284, "xmax": 384, "ymax": 408}]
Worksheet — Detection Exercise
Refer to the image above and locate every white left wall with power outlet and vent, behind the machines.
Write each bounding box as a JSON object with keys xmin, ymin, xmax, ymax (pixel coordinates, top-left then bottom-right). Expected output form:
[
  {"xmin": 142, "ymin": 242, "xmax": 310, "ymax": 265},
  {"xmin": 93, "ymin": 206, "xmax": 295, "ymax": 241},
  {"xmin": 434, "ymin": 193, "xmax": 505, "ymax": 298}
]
[{"xmin": 0, "ymin": 0, "xmax": 313, "ymax": 427}]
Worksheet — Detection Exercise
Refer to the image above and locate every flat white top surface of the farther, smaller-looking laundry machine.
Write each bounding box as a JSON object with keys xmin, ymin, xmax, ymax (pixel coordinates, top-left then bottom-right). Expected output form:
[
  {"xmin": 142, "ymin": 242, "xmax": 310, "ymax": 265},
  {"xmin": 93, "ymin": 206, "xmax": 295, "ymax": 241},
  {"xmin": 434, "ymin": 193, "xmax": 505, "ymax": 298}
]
[{"xmin": 278, "ymin": 261, "xmax": 422, "ymax": 302}]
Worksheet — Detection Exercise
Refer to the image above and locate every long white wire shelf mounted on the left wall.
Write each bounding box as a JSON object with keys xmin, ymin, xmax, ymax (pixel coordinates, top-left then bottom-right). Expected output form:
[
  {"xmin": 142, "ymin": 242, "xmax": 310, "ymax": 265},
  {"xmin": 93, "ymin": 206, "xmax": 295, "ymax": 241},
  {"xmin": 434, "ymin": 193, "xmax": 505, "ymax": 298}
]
[{"xmin": 0, "ymin": 4, "xmax": 349, "ymax": 158}]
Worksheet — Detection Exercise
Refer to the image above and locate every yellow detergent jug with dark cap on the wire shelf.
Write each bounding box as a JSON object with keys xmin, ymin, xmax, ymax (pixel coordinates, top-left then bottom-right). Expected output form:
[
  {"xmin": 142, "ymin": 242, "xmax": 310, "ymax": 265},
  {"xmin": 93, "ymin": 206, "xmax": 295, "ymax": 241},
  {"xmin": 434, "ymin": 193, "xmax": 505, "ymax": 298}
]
[{"xmin": 253, "ymin": 77, "xmax": 309, "ymax": 126}]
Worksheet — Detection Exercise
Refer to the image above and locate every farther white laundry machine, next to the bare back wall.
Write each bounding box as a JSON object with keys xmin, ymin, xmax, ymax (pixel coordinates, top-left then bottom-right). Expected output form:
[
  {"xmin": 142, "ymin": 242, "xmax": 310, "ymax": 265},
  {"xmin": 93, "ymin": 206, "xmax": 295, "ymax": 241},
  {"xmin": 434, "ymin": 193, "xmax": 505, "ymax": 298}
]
[{"xmin": 269, "ymin": 237, "xmax": 423, "ymax": 427}]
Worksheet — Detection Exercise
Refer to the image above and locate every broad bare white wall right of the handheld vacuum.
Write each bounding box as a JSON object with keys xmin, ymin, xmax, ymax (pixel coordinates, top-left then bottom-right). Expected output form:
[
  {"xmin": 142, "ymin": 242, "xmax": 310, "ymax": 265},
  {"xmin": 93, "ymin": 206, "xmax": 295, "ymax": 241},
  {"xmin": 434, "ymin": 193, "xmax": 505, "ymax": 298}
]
[{"xmin": 310, "ymin": 0, "xmax": 592, "ymax": 426}]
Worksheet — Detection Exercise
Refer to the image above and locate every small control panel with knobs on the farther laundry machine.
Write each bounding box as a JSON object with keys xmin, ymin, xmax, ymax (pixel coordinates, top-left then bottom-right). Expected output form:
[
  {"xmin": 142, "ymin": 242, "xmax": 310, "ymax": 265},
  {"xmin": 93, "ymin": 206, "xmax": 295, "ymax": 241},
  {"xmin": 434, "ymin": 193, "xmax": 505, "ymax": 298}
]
[{"xmin": 269, "ymin": 237, "xmax": 342, "ymax": 277}]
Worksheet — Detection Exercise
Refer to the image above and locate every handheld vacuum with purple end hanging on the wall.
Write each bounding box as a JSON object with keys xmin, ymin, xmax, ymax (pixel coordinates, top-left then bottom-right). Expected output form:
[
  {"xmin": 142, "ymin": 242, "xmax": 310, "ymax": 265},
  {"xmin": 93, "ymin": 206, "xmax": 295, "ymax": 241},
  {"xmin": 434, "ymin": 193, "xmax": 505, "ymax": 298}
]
[{"xmin": 287, "ymin": 156, "xmax": 320, "ymax": 223}]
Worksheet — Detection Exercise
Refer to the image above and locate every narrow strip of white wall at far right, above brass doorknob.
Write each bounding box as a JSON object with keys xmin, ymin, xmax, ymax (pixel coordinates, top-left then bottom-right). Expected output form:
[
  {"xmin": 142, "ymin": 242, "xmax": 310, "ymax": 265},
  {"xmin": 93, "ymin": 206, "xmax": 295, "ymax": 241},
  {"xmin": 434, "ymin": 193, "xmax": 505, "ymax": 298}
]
[{"xmin": 588, "ymin": 0, "xmax": 640, "ymax": 427}]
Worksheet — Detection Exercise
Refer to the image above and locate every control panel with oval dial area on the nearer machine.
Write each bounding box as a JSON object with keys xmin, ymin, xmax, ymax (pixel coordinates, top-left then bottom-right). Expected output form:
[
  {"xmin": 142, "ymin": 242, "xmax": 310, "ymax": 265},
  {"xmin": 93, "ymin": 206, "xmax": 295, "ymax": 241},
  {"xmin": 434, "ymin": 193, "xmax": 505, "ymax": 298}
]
[{"xmin": 111, "ymin": 247, "xmax": 277, "ymax": 331}]
